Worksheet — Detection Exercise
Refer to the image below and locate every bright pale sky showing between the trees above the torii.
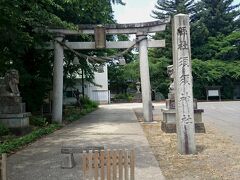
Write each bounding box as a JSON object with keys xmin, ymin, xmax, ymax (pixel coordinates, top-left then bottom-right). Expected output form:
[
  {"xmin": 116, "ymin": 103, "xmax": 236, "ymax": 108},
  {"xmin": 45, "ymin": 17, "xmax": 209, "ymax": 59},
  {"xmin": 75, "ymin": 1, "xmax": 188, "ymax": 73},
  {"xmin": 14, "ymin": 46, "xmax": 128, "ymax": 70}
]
[{"xmin": 113, "ymin": 0, "xmax": 240, "ymax": 23}]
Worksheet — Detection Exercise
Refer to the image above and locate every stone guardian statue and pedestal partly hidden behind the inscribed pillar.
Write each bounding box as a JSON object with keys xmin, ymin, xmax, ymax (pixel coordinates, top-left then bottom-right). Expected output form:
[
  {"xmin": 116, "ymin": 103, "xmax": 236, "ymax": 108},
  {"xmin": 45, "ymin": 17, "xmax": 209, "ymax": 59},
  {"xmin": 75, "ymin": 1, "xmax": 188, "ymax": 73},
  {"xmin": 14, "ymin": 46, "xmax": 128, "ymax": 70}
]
[{"xmin": 161, "ymin": 65, "xmax": 205, "ymax": 133}]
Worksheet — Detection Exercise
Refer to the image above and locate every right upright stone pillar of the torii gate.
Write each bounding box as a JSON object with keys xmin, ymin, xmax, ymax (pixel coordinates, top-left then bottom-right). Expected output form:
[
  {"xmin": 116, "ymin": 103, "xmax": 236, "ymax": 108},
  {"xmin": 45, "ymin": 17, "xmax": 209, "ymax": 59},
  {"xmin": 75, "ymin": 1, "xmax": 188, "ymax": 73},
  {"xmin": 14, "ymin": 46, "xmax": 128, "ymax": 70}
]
[{"xmin": 136, "ymin": 33, "xmax": 153, "ymax": 122}]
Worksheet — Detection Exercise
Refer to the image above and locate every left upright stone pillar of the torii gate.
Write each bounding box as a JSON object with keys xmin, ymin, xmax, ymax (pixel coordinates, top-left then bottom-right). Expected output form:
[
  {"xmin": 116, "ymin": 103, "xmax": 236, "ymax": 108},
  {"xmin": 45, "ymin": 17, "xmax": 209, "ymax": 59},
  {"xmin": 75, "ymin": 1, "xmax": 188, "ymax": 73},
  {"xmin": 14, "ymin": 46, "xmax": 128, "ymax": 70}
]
[{"xmin": 52, "ymin": 35, "xmax": 64, "ymax": 124}]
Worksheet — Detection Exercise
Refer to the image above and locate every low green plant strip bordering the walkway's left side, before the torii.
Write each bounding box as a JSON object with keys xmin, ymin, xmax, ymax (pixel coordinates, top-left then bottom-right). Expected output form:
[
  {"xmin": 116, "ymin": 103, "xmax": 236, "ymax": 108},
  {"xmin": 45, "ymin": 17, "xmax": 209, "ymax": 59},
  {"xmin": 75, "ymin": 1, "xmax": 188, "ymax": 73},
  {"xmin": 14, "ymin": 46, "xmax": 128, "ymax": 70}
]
[{"xmin": 0, "ymin": 124, "xmax": 62, "ymax": 154}]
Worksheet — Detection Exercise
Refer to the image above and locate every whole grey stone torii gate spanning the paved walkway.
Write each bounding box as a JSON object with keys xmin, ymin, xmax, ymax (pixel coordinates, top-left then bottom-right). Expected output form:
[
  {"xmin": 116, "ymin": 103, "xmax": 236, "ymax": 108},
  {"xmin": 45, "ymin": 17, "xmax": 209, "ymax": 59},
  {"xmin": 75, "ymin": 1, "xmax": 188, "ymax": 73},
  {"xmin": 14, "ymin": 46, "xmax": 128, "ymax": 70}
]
[{"xmin": 48, "ymin": 19, "xmax": 170, "ymax": 123}]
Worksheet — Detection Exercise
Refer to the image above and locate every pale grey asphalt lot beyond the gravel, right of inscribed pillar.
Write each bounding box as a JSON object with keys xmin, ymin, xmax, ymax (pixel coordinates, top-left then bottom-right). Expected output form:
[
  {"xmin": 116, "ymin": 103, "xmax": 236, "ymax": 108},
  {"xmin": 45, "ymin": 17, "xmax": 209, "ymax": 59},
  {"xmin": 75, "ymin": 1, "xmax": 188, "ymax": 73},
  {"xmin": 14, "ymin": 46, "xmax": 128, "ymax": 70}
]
[{"xmin": 198, "ymin": 101, "xmax": 240, "ymax": 143}]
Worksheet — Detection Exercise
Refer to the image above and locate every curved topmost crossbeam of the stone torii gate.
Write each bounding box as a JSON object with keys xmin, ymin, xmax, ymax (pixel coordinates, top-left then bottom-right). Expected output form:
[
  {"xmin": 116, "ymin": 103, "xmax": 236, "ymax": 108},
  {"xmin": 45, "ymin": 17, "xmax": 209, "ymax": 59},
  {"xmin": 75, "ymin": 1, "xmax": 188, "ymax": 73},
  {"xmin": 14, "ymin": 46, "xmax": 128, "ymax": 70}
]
[{"xmin": 49, "ymin": 18, "xmax": 170, "ymax": 35}]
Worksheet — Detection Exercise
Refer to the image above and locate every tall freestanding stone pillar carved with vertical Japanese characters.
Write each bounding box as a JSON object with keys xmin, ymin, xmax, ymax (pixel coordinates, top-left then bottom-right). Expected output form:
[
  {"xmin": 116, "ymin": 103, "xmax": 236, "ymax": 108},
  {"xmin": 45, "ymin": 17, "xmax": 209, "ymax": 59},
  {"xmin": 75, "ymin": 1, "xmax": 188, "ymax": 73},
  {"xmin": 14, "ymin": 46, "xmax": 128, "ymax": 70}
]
[{"xmin": 173, "ymin": 14, "xmax": 196, "ymax": 154}]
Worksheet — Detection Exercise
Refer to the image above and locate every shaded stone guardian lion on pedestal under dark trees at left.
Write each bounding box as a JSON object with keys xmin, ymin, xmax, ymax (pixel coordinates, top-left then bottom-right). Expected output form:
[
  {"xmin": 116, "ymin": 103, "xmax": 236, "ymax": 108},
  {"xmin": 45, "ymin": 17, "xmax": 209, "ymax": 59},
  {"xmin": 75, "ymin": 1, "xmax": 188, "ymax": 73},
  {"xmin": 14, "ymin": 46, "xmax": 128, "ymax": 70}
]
[{"xmin": 0, "ymin": 69, "xmax": 31, "ymax": 128}]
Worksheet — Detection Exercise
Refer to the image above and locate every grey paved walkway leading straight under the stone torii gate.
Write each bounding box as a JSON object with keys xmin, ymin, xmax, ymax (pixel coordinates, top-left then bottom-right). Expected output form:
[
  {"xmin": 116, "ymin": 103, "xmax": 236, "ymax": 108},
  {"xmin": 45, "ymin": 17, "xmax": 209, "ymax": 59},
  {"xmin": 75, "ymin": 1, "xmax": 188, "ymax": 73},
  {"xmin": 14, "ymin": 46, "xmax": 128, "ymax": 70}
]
[{"xmin": 8, "ymin": 104, "xmax": 164, "ymax": 180}]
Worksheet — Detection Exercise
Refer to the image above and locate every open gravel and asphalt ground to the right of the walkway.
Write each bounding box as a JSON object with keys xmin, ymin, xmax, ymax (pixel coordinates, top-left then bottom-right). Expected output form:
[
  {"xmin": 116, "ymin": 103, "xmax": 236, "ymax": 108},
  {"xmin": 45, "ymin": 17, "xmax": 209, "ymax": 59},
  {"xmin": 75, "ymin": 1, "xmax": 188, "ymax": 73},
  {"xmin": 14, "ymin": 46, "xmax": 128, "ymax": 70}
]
[{"xmin": 135, "ymin": 102, "xmax": 240, "ymax": 180}]
